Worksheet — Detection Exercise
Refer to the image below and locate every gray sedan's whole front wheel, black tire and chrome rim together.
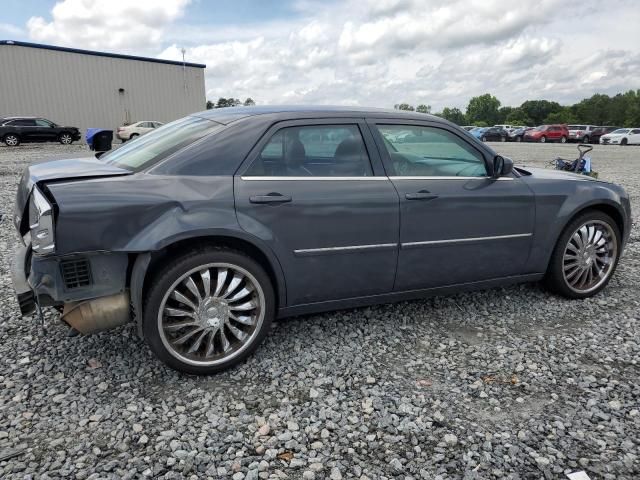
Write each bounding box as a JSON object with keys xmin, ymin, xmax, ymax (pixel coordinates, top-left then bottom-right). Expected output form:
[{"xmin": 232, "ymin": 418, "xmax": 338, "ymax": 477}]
[{"xmin": 545, "ymin": 210, "xmax": 621, "ymax": 298}]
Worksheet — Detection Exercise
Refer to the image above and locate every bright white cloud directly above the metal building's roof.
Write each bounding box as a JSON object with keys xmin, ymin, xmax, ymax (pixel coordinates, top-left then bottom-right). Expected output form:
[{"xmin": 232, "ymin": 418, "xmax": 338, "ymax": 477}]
[{"xmin": 27, "ymin": 0, "xmax": 190, "ymax": 52}]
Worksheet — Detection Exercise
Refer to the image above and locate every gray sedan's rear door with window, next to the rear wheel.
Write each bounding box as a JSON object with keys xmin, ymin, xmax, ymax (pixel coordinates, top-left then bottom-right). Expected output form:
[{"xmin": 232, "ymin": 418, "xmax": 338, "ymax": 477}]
[{"xmin": 234, "ymin": 119, "xmax": 399, "ymax": 306}]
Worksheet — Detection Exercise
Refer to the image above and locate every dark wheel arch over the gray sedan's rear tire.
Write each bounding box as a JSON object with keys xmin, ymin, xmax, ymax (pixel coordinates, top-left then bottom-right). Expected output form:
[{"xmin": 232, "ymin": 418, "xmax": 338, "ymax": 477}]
[{"xmin": 129, "ymin": 232, "xmax": 286, "ymax": 338}]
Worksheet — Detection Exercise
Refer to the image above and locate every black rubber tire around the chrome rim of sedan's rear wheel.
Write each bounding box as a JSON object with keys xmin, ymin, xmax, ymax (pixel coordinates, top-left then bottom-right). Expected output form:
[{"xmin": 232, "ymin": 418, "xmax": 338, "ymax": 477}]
[{"xmin": 142, "ymin": 248, "xmax": 276, "ymax": 375}]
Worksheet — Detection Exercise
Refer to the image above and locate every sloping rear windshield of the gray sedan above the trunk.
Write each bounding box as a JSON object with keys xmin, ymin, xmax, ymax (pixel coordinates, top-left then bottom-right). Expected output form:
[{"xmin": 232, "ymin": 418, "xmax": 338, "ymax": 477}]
[{"xmin": 101, "ymin": 117, "xmax": 223, "ymax": 172}]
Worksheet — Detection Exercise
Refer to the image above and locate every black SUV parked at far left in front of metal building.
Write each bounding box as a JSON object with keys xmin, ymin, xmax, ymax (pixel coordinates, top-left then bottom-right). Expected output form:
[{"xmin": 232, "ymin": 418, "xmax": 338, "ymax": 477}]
[{"xmin": 0, "ymin": 117, "xmax": 81, "ymax": 147}]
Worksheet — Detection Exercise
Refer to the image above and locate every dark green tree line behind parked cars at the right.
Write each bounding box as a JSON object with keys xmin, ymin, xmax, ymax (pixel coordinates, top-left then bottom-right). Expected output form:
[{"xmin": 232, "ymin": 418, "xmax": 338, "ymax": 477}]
[{"xmin": 394, "ymin": 89, "xmax": 640, "ymax": 127}]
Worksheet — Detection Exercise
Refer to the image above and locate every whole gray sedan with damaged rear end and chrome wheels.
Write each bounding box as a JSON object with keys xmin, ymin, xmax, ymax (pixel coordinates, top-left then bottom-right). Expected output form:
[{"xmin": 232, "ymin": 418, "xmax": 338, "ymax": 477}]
[{"xmin": 12, "ymin": 107, "xmax": 631, "ymax": 374}]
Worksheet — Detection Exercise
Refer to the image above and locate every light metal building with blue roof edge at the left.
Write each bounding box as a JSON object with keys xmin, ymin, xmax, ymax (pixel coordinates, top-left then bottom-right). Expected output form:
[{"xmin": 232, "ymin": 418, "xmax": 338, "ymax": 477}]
[{"xmin": 0, "ymin": 40, "xmax": 206, "ymax": 138}]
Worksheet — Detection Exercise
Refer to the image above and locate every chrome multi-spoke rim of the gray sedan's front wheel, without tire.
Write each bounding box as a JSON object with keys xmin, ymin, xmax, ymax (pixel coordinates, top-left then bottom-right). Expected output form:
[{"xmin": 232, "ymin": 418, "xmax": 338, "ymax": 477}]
[{"xmin": 562, "ymin": 220, "xmax": 618, "ymax": 293}]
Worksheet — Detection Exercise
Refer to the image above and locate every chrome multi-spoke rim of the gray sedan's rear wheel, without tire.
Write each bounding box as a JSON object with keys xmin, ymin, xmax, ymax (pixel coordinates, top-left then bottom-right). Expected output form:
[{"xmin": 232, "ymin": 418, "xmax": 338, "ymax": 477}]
[{"xmin": 158, "ymin": 263, "xmax": 265, "ymax": 366}]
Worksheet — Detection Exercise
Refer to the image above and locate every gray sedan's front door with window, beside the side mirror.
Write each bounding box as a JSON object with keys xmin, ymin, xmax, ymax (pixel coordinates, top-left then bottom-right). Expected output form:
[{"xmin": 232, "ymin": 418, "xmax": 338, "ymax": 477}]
[{"xmin": 372, "ymin": 122, "xmax": 535, "ymax": 291}]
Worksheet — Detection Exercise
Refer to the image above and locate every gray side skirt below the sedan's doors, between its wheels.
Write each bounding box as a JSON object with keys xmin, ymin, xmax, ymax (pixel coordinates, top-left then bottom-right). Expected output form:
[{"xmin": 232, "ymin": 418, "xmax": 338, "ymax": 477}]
[{"xmin": 278, "ymin": 273, "xmax": 544, "ymax": 318}]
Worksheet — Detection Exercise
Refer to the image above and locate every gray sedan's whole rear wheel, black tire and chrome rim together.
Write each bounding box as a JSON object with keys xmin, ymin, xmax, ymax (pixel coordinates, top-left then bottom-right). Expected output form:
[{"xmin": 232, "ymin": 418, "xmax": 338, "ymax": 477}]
[{"xmin": 143, "ymin": 248, "xmax": 276, "ymax": 375}]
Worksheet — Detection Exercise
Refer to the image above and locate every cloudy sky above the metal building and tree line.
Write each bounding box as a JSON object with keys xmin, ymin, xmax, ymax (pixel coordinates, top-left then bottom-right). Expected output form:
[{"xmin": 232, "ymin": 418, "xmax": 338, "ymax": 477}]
[{"xmin": 5, "ymin": 0, "xmax": 640, "ymax": 110}]
